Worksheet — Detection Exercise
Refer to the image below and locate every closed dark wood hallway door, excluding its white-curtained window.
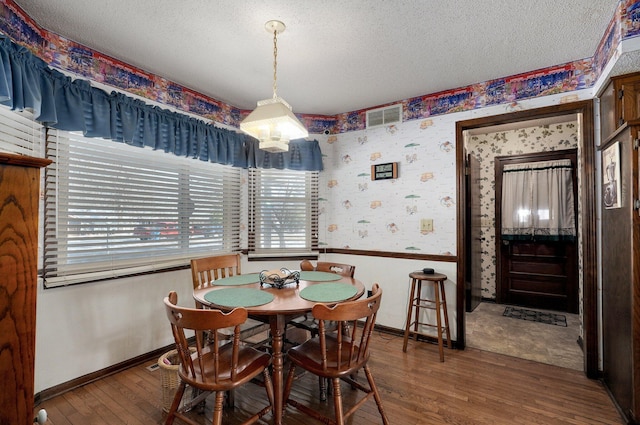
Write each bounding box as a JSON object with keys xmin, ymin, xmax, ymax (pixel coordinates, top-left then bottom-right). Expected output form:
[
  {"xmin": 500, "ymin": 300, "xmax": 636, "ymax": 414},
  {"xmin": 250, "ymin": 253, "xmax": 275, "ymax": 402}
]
[{"xmin": 495, "ymin": 149, "xmax": 579, "ymax": 313}]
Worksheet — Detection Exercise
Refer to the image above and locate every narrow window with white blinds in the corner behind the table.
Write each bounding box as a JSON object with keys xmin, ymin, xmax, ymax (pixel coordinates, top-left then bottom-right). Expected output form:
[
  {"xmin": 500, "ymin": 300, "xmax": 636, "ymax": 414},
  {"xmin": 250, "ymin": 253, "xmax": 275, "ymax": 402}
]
[{"xmin": 249, "ymin": 169, "xmax": 318, "ymax": 256}]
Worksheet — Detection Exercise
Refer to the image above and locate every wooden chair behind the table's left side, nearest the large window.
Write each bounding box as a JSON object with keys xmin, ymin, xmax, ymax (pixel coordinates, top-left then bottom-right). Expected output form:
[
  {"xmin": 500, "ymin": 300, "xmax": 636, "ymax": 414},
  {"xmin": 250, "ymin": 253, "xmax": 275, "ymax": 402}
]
[{"xmin": 191, "ymin": 254, "xmax": 269, "ymax": 345}]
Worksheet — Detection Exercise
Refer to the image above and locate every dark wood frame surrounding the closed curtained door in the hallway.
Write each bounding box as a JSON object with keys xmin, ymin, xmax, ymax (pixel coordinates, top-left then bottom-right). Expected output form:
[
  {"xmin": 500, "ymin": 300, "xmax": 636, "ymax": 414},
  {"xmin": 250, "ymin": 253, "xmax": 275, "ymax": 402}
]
[{"xmin": 494, "ymin": 148, "xmax": 580, "ymax": 313}]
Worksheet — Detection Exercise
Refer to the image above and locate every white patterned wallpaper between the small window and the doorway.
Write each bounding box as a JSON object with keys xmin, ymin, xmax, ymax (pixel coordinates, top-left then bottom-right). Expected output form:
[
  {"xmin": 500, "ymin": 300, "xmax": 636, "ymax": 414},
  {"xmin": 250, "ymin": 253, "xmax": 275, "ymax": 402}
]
[{"xmin": 319, "ymin": 114, "xmax": 460, "ymax": 255}]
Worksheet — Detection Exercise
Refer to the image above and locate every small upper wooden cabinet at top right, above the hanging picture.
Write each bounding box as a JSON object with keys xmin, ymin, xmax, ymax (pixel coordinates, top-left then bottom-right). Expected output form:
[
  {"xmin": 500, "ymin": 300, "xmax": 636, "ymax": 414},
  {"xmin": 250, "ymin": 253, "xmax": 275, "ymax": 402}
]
[{"xmin": 600, "ymin": 72, "xmax": 640, "ymax": 140}]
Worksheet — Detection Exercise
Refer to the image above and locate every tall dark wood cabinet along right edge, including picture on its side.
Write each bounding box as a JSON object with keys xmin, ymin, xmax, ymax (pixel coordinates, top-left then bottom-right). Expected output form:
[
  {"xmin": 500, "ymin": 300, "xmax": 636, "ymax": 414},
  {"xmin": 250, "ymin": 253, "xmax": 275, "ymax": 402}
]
[{"xmin": 598, "ymin": 73, "xmax": 640, "ymax": 423}]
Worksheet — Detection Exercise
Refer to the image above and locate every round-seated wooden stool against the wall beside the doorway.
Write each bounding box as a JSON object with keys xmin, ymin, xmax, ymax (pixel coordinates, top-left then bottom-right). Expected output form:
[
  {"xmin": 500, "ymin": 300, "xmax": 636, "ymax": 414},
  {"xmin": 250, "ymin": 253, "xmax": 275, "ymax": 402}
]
[{"xmin": 402, "ymin": 271, "xmax": 452, "ymax": 362}]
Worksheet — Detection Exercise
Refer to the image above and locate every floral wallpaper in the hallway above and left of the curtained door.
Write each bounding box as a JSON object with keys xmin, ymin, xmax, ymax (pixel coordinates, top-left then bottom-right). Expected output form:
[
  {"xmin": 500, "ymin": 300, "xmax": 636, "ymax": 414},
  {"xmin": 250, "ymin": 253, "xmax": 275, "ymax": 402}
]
[{"xmin": 466, "ymin": 122, "xmax": 580, "ymax": 299}]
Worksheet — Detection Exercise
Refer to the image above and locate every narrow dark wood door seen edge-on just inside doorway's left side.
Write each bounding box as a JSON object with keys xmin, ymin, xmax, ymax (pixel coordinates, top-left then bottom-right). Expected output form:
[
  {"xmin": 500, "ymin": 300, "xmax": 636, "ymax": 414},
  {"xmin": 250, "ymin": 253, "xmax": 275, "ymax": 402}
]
[{"xmin": 465, "ymin": 155, "xmax": 482, "ymax": 312}]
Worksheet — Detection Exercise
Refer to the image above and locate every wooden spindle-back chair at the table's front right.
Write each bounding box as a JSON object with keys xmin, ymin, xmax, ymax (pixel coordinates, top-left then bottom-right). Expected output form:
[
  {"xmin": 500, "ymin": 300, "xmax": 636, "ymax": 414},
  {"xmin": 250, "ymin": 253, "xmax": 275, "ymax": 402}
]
[{"xmin": 284, "ymin": 283, "xmax": 389, "ymax": 425}]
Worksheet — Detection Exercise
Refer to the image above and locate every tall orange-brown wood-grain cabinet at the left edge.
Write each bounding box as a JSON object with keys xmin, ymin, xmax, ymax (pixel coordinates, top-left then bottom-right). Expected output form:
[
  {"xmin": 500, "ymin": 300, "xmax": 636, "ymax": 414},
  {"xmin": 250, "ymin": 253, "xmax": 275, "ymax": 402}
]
[{"xmin": 0, "ymin": 153, "xmax": 51, "ymax": 424}]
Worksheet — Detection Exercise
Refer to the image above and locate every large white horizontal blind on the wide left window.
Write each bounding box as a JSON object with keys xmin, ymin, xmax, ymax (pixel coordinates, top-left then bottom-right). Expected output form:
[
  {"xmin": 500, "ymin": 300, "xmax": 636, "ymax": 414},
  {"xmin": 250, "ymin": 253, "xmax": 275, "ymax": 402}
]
[{"xmin": 44, "ymin": 130, "xmax": 241, "ymax": 287}]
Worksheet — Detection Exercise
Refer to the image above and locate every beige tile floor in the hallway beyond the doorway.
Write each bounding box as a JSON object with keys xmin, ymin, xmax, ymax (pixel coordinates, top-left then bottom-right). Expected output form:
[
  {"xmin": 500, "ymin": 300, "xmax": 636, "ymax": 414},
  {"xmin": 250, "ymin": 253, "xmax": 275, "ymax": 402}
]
[{"xmin": 466, "ymin": 302, "xmax": 584, "ymax": 370}]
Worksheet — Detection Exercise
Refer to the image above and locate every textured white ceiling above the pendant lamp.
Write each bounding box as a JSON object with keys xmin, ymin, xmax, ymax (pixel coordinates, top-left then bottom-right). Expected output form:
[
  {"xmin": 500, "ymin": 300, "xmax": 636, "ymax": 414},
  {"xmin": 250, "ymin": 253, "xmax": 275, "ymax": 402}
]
[{"xmin": 11, "ymin": 0, "xmax": 618, "ymax": 115}]
